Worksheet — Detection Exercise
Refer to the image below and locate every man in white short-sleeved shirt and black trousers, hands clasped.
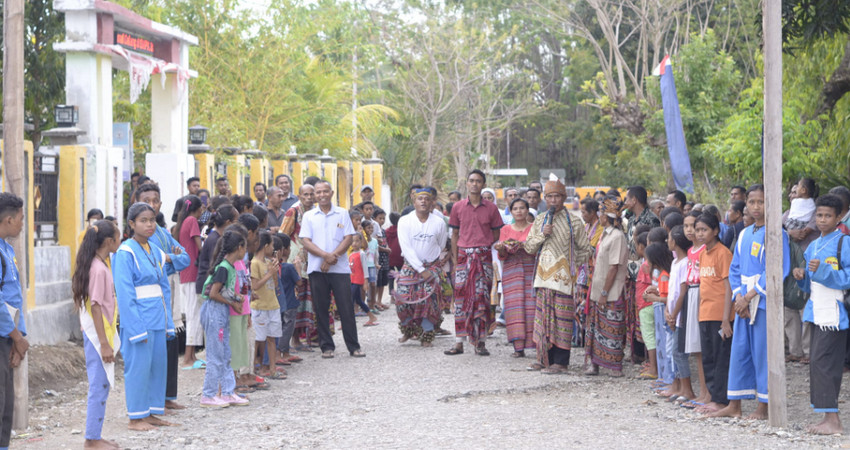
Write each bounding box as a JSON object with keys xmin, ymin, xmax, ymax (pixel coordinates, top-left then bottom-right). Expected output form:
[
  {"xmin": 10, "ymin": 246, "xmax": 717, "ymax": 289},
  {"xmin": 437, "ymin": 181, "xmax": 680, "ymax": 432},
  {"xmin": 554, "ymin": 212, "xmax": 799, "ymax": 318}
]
[{"xmin": 298, "ymin": 180, "xmax": 366, "ymax": 359}]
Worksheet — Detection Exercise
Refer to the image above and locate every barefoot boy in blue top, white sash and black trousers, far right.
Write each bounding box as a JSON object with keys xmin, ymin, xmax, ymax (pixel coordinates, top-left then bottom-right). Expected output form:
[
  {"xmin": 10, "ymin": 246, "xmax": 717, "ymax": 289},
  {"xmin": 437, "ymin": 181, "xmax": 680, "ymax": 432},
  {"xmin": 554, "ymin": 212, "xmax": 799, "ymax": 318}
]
[{"xmin": 794, "ymin": 195, "xmax": 850, "ymax": 435}]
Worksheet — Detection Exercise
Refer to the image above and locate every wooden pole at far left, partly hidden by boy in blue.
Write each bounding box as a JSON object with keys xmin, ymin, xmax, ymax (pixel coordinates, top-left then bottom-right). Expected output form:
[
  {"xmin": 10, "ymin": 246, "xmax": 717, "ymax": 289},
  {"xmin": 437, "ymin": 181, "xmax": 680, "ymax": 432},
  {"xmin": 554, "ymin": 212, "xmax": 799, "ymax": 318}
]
[{"xmin": 2, "ymin": 0, "xmax": 29, "ymax": 430}]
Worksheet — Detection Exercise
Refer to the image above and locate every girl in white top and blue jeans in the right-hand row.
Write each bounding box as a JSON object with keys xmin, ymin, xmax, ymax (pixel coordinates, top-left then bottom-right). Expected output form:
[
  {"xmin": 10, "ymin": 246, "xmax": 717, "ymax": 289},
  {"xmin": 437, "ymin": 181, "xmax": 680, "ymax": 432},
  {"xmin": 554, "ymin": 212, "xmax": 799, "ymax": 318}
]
[{"xmin": 661, "ymin": 225, "xmax": 696, "ymax": 403}]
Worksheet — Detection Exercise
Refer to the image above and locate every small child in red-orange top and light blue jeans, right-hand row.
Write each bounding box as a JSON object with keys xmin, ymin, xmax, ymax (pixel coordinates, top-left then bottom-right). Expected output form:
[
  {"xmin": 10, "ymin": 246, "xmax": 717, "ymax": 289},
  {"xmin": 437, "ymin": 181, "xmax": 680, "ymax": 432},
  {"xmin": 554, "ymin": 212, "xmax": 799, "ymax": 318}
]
[{"xmin": 641, "ymin": 242, "xmax": 673, "ymax": 385}]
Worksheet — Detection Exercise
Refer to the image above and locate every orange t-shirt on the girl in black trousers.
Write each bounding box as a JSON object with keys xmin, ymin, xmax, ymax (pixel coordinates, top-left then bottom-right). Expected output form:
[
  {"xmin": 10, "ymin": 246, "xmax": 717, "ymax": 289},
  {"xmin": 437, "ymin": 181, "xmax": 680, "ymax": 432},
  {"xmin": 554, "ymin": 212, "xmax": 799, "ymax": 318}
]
[{"xmin": 699, "ymin": 242, "xmax": 734, "ymax": 322}]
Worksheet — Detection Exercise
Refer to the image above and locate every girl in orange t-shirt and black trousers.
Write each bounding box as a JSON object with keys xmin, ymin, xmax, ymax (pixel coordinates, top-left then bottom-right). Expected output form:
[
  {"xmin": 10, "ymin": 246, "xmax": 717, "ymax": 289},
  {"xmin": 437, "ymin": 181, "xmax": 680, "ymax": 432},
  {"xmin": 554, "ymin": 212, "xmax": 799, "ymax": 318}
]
[{"xmin": 688, "ymin": 214, "xmax": 732, "ymax": 413}]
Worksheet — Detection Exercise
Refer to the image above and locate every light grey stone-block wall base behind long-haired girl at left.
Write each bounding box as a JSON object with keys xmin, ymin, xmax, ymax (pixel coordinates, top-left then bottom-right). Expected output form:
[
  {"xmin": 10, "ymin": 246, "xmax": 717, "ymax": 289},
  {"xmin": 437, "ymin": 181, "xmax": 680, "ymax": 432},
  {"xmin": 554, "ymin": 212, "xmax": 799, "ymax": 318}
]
[{"xmin": 26, "ymin": 245, "xmax": 83, "ymax": 345}]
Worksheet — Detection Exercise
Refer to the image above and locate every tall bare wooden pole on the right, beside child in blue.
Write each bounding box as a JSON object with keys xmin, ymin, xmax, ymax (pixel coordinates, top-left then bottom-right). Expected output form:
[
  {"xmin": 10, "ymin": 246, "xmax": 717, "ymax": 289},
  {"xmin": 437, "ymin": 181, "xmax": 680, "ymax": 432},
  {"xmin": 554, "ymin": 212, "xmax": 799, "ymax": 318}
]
[{"xmin": 763, "ymin": 0, "xmax": 788, "ymax": 427}]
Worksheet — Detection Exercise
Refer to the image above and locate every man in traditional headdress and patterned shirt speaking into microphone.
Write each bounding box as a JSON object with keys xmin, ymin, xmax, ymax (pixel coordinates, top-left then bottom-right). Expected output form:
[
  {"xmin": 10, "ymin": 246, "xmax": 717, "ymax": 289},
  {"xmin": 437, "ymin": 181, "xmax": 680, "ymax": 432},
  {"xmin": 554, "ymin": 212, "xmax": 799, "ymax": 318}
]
[{"xmin": 525, "ymin": 180, "xmax": 591, "ymax": 374}]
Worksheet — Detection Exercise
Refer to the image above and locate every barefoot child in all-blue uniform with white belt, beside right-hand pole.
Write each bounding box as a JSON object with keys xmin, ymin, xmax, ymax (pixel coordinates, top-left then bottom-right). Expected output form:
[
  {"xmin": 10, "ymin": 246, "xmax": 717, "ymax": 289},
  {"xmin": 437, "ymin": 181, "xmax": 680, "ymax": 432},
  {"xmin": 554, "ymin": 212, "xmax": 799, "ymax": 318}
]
[{"xmin": 700, "ymin": 185, "xmax": 791, "ymax": 420}]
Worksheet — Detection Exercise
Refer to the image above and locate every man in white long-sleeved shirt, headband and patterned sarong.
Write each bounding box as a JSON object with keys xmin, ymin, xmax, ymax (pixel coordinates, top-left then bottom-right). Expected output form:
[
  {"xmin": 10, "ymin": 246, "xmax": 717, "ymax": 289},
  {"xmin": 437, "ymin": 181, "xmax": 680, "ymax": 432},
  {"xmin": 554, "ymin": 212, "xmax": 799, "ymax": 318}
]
[{"xmin": 393, "ymin": 188, "xmax": 448, "ymax": 347}]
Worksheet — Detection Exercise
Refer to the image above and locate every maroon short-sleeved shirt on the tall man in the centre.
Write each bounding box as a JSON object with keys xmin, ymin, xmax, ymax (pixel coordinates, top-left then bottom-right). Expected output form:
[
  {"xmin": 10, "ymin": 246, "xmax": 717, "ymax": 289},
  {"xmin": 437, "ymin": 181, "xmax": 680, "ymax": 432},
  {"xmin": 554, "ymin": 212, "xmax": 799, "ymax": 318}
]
[{"xmin": 449, "ymin": 198, "xmax": 504, "ymax": 248}]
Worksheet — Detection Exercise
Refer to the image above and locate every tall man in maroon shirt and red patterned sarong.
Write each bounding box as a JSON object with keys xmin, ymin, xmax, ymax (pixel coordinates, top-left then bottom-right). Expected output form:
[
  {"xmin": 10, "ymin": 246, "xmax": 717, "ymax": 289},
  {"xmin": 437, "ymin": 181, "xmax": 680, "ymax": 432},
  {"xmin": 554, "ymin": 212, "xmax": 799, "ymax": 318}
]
[{"xmin": 443, "ymin": 169, "xmax": 503, "ymax": 356}]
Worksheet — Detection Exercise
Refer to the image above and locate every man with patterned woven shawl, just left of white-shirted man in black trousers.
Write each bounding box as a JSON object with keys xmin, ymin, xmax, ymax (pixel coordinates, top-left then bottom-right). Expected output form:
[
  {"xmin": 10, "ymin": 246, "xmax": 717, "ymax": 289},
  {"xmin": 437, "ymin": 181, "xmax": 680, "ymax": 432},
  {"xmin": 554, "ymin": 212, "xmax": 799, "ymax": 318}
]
[{"xmin": 278, "ymin": 184, "xmax": 316, "ymax": 351}]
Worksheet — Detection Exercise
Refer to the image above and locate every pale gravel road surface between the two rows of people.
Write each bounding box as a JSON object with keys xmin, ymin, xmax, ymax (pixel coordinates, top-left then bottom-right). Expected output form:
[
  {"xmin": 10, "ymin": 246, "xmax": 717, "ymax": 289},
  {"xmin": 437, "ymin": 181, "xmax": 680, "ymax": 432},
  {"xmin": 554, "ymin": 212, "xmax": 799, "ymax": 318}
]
[{"xmin": 12, "ymin": 304, "xmax": 850, "ymax": 450}]
